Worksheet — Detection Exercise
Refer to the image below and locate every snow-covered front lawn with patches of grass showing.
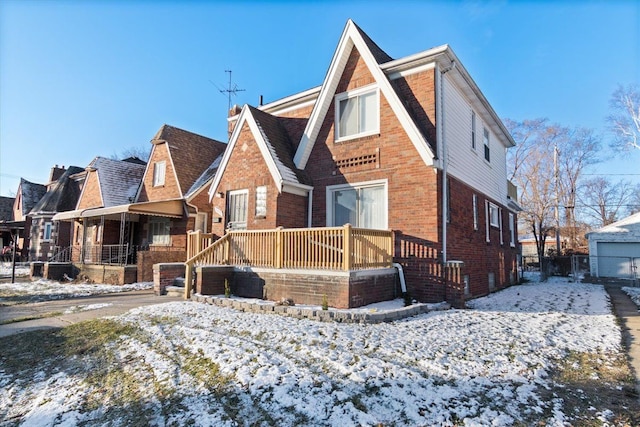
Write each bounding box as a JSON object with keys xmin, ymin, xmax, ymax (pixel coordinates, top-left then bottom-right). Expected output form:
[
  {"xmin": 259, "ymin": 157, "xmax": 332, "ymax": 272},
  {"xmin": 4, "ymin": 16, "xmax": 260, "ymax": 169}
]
[{"xmin": 0, "ymin": 278, "xmax": 640, "ymax": 426}]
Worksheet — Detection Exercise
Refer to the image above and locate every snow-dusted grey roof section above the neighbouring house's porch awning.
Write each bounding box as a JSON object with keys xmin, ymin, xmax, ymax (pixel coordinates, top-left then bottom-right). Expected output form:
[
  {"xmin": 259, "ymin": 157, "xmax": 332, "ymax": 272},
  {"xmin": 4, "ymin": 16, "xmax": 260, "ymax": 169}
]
[{"xmin": 83, "ymin": 157, "xmax": 145, "ymax": 207}]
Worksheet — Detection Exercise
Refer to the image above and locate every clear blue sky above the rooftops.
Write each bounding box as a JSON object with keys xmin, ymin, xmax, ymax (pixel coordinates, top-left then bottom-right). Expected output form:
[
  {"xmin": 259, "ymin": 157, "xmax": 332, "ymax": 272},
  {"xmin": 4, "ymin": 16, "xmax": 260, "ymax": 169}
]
[{"xmin": 0, "ymin": 0, "xmax": 640, "ymax": 196}]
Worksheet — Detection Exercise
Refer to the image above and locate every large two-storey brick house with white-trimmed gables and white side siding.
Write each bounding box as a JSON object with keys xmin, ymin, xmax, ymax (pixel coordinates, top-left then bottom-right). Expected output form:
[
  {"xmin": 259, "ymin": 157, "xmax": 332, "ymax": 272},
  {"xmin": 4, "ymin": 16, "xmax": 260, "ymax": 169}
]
[{"xmin": 205, "ymin": 21, "xmax": 520, "ymax": 304}]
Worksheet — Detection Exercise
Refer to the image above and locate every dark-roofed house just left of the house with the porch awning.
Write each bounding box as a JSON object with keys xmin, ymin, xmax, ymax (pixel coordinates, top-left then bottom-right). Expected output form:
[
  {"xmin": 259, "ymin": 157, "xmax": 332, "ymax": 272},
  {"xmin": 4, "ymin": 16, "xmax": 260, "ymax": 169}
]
[{"xmin": 27, "ymin": 165, "xmax": 84, "ymax": 261}]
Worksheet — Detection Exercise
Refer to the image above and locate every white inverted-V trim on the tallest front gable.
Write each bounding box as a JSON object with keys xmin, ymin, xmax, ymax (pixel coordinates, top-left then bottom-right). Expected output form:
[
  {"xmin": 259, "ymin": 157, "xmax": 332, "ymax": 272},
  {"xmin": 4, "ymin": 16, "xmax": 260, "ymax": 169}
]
[{"xmin": 293, "ymin": 20, "xmax": 434, "ymax": 169}]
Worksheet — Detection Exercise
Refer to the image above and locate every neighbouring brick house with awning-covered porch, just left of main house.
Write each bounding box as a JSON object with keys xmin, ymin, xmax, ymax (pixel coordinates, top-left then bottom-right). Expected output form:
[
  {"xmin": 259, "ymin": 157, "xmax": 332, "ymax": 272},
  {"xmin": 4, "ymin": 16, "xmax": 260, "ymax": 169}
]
[{"xmin": 54, "ymin": 125, "xmax": 226, "ymax": 283}]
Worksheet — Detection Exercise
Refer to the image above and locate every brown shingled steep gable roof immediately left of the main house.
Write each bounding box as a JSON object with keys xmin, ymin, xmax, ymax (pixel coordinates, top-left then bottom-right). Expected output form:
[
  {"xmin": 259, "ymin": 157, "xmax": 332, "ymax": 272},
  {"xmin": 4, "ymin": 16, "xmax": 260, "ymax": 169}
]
[{"xmin": 151, "ymin": 124, "xmax": 227, "ymax": 195}]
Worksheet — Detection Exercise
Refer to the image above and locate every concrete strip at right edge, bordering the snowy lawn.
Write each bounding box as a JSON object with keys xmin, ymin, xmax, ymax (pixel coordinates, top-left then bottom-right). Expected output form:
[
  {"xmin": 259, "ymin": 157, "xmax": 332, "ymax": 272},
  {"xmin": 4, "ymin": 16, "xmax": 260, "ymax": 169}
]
[{"xmin": 605, "ymin": 284, "xmax": 640, "ymax": 394}]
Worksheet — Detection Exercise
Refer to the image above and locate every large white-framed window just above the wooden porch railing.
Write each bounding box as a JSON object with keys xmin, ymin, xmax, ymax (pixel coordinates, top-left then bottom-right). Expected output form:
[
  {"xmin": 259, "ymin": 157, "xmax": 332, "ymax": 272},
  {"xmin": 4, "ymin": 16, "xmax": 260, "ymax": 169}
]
[{"xmin": 327, "ymin": 180, "xmax": 388, "ymax": 230}]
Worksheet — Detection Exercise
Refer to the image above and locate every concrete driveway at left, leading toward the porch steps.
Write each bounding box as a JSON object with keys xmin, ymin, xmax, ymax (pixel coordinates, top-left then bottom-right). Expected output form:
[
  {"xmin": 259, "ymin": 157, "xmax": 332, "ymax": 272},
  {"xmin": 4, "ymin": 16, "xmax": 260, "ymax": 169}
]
[{"xmin": 0, "ymin": 289, "xmax": 182, "ymax": 337}]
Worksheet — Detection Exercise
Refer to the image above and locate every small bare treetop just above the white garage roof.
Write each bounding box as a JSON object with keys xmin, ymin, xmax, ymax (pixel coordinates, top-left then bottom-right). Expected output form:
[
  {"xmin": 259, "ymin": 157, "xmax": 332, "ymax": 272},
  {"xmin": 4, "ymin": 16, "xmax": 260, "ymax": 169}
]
[{"xmin": 578, "ymin": 177, "xmax": 640, "ymax": 227}]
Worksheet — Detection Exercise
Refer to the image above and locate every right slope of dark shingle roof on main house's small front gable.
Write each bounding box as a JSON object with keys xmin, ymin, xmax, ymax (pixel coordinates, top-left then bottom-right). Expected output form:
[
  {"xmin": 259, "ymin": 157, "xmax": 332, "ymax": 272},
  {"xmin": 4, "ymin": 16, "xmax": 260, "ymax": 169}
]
[{"xmin": 249, "ymin": 106, "xmax": 311, "ymax": 185}]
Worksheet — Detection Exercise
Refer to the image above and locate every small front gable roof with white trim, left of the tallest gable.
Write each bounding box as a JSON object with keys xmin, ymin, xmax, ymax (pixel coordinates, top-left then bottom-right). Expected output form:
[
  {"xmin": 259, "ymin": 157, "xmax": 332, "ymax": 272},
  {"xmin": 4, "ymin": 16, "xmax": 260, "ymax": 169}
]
[{"xmin": 209, "ymin": 105, "xmax": 311, "ymax": 201}]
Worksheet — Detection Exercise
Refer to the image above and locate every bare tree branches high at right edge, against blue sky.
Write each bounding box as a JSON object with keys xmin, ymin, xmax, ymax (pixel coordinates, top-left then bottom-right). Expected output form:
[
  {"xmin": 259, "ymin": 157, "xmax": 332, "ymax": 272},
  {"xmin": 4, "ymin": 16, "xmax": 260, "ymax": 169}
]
[{"xmin": 607, "ymin": 85, "xmax": 640, "ymax": 151}]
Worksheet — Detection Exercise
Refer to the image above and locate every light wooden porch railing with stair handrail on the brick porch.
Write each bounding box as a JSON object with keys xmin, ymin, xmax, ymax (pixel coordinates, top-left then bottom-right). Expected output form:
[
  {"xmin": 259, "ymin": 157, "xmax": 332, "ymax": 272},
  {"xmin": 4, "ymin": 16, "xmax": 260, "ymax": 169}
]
[{"xmin": 185, "ymin": 224, "xmax": 393, "ymax": 298}]
